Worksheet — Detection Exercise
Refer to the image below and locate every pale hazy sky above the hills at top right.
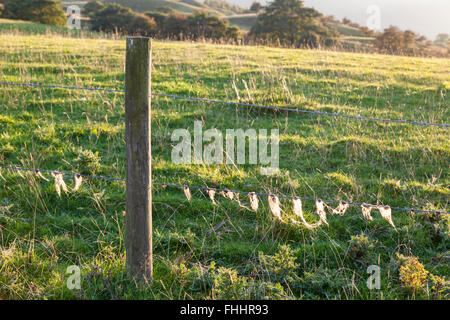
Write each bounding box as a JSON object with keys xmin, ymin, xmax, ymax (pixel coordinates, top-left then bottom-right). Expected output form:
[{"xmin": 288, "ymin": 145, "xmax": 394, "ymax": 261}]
[{"xmin": 227, "ymin": 0, "xmax": 450, "ymax": 40}]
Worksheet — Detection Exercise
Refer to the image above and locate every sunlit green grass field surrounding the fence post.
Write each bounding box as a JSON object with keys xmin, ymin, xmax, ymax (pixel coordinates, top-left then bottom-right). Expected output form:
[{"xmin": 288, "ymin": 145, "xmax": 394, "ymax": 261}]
[{"xmin": 0, "ymin": 28, "xmax": 450, "ymax": 299}]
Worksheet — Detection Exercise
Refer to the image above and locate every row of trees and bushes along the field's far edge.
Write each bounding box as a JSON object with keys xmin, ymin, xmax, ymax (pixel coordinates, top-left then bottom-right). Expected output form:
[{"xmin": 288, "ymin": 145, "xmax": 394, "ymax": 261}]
[{"xmin": 0, "ymin": 0, "xmax": 450, "ymax": 55}]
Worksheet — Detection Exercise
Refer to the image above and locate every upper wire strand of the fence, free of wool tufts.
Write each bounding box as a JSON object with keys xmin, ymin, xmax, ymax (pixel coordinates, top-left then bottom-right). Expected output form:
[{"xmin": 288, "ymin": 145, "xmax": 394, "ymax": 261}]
[{"xmin": 0, "ymin": 82, "xmax": 450, "ymax": 128}]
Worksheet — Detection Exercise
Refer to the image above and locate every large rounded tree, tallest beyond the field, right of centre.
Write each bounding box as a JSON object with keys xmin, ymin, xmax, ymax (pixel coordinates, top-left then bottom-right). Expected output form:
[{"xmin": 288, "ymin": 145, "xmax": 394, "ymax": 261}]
[{"xmin": 250, "ymin": 0, "xmax": 339, "ymax": 47}]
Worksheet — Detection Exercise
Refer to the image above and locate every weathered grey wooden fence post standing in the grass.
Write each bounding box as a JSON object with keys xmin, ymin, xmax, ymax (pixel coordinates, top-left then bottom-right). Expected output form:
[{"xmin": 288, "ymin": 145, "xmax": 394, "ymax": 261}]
[{"xmin": 125, "ymin": 37, "xmax": 153, "ymax": 281}]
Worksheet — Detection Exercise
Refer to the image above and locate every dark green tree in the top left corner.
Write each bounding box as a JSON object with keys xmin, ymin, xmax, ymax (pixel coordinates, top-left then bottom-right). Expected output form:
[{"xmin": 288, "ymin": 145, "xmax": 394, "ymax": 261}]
[{"xmin": 2, "ymin": 0, "xmax": 67, "ymax": 27}]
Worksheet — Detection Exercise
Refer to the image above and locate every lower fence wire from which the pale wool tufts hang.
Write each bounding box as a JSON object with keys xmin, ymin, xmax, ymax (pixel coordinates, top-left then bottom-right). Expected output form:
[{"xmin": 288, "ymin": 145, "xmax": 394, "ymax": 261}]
[{"xmin": 0, "ymin": 165, "xmax": 450, "ymax": 214}]
